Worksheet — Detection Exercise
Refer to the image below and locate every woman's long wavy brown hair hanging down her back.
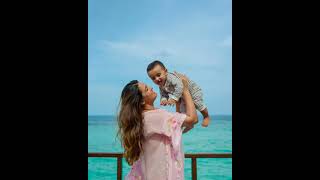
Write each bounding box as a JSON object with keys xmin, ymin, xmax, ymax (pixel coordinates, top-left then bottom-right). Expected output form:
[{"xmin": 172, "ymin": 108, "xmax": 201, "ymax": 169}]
[{"xmin": 117, "ymin": 80, "xmax": 144, "ymax": 165}]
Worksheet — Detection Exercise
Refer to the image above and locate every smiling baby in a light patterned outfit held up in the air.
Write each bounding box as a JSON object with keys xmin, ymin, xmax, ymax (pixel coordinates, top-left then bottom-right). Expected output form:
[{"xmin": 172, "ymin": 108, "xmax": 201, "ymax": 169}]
[{"xmin": 147, "ymin": 61, "xmax": 210, "ymax": 127}]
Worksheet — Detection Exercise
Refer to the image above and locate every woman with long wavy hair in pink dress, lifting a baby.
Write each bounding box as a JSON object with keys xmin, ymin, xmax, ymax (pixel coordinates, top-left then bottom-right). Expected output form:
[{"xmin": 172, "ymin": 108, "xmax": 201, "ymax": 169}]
[{"xmin": 118, "ymin": 76, "xmax": 198, "ymax": 180}]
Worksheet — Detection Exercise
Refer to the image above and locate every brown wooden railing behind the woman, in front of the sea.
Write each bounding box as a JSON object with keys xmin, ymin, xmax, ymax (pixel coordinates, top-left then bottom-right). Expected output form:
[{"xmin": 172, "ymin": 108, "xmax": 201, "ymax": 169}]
[{"xmin": 88, "ymin": 153, "xmax": 232, "ymax": 180}]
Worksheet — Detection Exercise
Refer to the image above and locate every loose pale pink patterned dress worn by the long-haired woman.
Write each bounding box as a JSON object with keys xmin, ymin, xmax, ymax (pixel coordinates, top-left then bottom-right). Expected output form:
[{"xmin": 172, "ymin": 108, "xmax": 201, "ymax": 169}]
[{"xmin": 125, "ymin": 109, "xmax": 186, "ymax": 180}]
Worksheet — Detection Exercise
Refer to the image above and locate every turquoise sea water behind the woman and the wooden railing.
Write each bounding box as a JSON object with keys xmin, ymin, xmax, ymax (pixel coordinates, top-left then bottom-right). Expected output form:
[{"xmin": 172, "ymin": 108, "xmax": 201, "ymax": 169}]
[{"xmin": 88, "ymin": 115, "xmax": 232, "ymax": 180}]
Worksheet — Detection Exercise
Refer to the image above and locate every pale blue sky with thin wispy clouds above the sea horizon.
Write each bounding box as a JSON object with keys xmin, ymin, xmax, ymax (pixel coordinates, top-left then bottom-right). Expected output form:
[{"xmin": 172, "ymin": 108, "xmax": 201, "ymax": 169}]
[{"xmin": 88, "ymin": 0, "xmax": 232, "ymax": 115}]
